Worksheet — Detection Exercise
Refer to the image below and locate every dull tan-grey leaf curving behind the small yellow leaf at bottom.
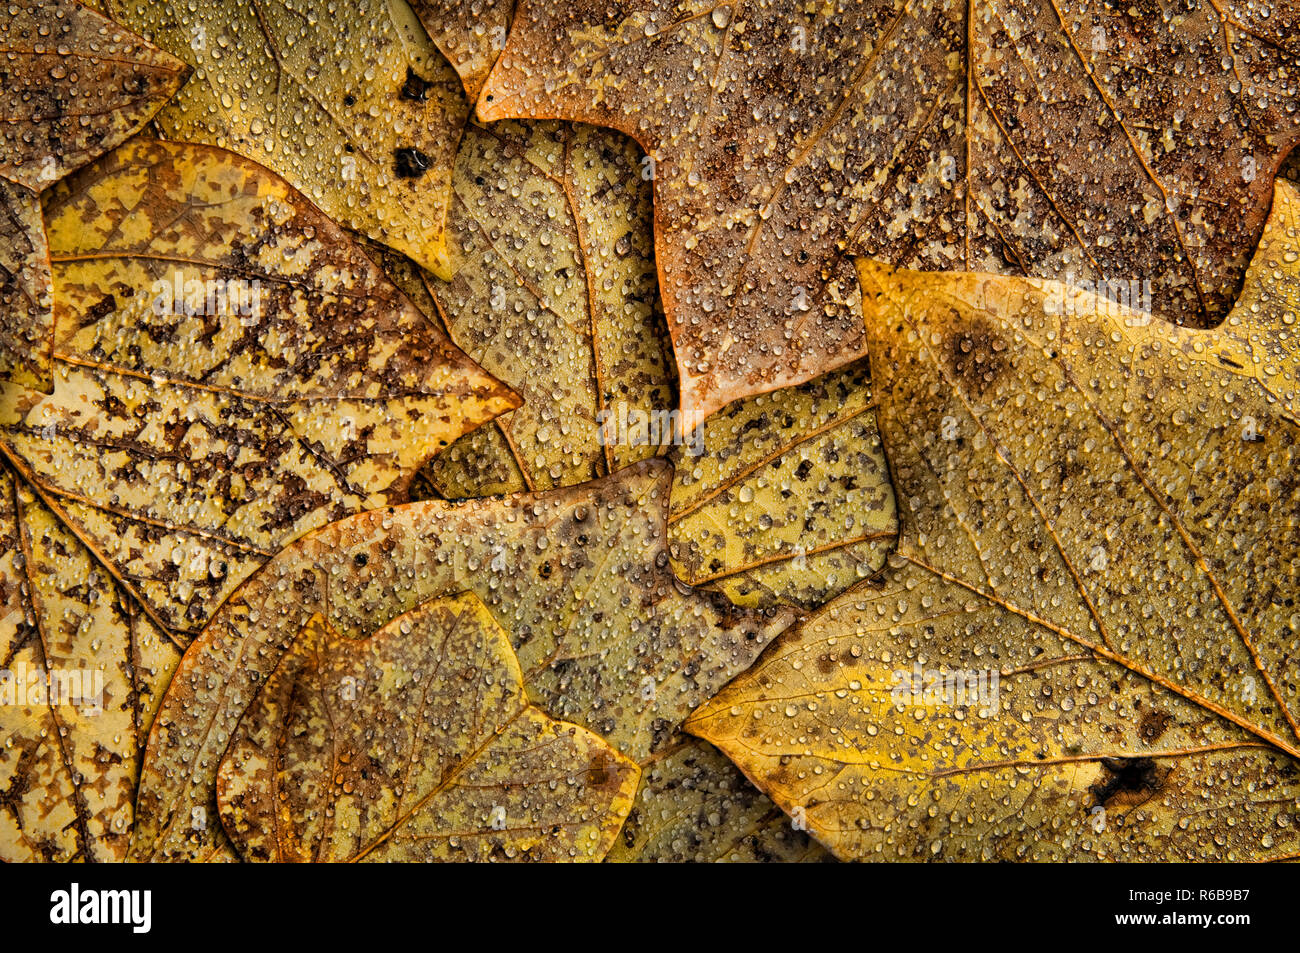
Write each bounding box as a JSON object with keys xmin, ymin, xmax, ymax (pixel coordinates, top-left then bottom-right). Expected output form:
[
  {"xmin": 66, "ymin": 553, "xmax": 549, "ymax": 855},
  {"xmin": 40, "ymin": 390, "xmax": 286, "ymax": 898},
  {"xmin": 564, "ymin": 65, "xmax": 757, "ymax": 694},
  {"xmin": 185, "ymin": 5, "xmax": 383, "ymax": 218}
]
[{"xmin": 133, "ymin": 460, "xmax": 793, "ymax": 859}]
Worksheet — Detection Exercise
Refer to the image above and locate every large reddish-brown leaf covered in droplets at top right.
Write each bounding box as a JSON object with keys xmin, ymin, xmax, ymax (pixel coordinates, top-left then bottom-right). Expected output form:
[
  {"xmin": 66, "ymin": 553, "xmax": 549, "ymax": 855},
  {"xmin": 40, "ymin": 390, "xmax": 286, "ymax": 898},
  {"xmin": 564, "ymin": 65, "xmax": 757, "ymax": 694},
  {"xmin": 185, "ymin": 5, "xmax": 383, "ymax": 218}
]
[{"xmin": 478, "ymin": 0, "xmax": 1300, "ymax": 415}]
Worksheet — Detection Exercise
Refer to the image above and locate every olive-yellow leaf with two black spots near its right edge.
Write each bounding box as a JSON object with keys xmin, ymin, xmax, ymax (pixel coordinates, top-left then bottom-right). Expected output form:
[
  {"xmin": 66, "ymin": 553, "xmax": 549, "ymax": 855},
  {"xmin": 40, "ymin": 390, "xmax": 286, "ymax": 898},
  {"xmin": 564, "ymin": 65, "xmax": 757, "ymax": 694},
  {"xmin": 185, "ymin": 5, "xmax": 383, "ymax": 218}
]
[{"xmin": 109, "ymin": 0, "xmax": 469, "ymax": 277}]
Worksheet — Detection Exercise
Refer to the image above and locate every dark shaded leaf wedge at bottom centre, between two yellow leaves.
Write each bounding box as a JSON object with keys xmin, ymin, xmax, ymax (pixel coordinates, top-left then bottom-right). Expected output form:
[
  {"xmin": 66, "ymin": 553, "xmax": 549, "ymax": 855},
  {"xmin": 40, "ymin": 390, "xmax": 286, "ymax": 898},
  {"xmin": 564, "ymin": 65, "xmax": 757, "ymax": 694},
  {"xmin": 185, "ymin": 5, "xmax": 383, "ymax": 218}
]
[{"xmin": 606, "ymin": 738, "xmax": 833, "ymax": 863}]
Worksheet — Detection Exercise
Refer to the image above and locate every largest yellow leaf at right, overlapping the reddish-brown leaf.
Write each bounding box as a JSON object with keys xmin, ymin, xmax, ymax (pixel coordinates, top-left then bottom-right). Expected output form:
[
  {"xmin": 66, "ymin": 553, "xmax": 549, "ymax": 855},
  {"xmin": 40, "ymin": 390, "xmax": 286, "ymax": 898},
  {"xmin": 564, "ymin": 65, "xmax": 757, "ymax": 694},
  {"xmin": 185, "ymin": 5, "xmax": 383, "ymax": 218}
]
[{"xmin": 688, "ymin": 181, "xmax": 1300, "ymax": 861}]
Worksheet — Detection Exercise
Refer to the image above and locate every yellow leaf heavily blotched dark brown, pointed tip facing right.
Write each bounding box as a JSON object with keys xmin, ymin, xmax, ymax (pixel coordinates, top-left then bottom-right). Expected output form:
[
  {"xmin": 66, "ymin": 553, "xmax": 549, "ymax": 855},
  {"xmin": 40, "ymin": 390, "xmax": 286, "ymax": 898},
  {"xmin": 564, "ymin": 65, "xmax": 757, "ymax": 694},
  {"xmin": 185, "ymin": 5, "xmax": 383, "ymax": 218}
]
[{"xmin": 0, "ymin": 140, "xmax": 517, "ymax": 632}]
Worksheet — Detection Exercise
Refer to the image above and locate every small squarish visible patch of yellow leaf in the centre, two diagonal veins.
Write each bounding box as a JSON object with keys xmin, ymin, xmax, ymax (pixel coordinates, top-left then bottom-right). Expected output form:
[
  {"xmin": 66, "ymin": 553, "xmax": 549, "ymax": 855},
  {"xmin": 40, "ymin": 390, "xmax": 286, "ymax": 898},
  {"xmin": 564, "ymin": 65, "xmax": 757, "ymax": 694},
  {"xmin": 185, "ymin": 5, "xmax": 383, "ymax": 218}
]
[{"xmin": 668, "ymin": 361, "xmax": 898, "ymax": 608}]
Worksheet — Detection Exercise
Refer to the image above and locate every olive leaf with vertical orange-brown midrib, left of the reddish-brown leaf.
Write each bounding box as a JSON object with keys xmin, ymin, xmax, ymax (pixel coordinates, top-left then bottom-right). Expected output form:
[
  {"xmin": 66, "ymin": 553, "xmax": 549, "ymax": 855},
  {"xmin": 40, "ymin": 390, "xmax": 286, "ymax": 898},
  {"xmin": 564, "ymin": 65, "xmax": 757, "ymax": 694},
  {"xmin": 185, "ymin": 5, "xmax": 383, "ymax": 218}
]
[{"xmin": 413, "ymin": 122, "xmax": 675, "ymax": 498}]
